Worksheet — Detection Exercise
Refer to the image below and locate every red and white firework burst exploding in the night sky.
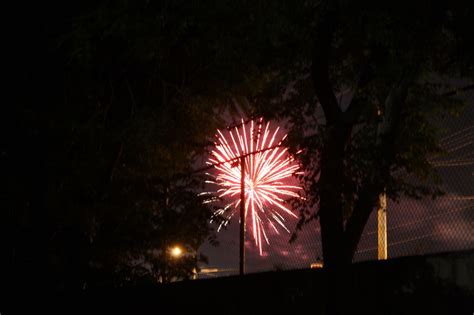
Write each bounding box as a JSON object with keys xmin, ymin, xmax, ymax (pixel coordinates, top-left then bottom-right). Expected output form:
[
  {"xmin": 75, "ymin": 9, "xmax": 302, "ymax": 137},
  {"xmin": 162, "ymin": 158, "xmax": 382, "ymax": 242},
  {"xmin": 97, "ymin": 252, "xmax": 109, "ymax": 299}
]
[{"xmin": 207, "ymin": 119, "xmax": 301, "ymax": 255}]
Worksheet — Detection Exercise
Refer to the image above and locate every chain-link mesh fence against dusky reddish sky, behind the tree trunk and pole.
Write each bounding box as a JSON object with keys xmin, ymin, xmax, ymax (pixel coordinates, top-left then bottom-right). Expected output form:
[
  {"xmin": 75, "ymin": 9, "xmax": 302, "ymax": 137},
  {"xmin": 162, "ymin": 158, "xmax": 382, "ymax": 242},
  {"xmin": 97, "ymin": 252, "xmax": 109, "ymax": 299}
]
[{"xmin": 196, "ymin": 96, "xmax": 474, "ymax": 278}]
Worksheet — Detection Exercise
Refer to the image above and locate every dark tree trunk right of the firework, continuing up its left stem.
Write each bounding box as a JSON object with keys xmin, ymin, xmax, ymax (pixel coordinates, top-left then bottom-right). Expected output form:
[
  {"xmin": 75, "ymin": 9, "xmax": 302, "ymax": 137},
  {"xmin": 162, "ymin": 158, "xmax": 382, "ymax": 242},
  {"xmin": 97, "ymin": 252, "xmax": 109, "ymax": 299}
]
[{"xmin": 311, "ymin": 3, "xmax": 347, "ymax": 268}]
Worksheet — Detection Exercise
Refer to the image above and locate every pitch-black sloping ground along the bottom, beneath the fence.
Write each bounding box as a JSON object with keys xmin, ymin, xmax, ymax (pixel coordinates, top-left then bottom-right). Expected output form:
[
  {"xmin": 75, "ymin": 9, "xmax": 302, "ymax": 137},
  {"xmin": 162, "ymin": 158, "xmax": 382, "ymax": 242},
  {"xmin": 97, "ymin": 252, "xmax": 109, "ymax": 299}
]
[{"xmin": 1, "ymin": 250, "xmax": 474, "ymax": 314}]
